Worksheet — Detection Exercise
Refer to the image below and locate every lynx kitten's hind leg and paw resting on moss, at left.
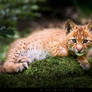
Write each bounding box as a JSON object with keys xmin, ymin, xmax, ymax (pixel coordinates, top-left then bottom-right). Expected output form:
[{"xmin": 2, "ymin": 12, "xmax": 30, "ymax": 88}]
[{"xmin": 2, "ymin": 57, "xmax": 30, "ymax": 73}]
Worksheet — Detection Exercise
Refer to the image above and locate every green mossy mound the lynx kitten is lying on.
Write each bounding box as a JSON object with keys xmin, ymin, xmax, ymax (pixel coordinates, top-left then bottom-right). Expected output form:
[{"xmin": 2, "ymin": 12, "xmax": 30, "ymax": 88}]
[{"xmin": 0, "ymin": 57, "xmax": 92, "ymax": 88}]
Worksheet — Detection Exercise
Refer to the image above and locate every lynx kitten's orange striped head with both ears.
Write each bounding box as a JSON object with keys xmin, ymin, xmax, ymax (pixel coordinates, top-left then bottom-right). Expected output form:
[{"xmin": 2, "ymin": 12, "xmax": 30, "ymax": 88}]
[{"xmin": 65, "ymin": 20, "xmax": 92, "ymax": 56}]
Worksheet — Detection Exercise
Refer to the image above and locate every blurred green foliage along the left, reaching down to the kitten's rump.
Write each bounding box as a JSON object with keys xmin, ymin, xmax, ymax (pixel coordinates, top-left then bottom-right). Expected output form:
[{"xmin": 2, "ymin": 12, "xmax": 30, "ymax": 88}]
[{"xmin": 0, "ymin": 0, "xmax": 51, "ymax": 61}]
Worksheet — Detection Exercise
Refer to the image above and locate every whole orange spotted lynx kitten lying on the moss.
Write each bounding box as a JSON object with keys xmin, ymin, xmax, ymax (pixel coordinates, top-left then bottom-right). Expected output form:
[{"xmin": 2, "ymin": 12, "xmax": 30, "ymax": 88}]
[{"xmin": 0, "ymin": 21, "xmax": 92, "ymax": 73}]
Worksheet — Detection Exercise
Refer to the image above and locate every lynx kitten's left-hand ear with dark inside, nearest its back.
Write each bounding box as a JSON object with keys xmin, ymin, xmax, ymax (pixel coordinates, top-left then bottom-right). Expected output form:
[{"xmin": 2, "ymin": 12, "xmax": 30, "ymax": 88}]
[{"xmin": 65, "ymin": 19, "xmax": 75, "ymax": 34}]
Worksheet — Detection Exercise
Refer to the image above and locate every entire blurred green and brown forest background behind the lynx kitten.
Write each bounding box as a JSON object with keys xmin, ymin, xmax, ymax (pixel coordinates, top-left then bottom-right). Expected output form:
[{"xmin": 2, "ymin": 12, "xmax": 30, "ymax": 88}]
[{"xmin": 0, "ymin": 0, "xmax": 92, "ymax": 61}]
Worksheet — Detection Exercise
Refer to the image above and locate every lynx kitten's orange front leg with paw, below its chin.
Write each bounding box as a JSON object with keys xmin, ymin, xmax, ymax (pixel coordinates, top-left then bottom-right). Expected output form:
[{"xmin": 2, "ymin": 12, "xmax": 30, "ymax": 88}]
[{"xmin": 78, "ymin": 56, "xmax": 90, "ymax": 70}]
